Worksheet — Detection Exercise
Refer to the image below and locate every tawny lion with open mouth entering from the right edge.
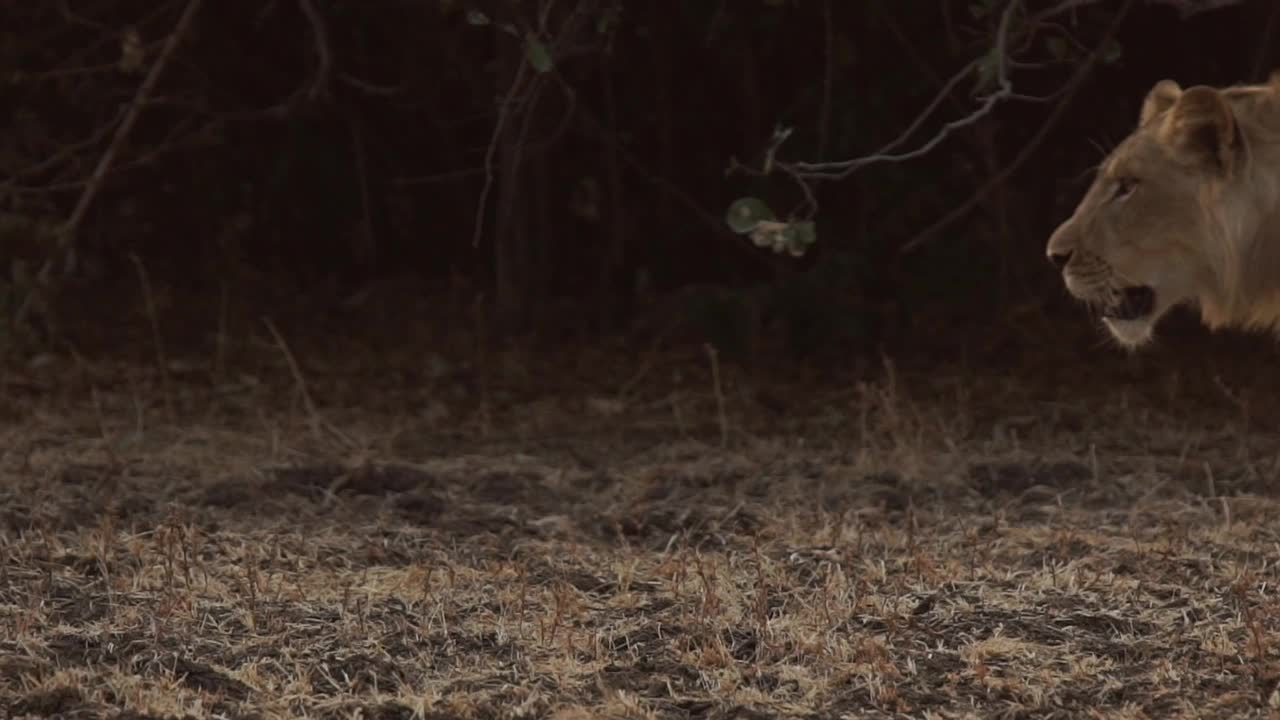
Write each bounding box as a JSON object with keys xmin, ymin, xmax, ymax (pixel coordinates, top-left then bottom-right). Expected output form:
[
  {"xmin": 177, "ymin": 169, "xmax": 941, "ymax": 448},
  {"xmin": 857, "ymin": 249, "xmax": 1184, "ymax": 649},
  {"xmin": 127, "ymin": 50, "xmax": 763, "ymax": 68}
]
[{"xmin": 1047, "ymin": 72, "xmax": 1280, "ymax": 348}]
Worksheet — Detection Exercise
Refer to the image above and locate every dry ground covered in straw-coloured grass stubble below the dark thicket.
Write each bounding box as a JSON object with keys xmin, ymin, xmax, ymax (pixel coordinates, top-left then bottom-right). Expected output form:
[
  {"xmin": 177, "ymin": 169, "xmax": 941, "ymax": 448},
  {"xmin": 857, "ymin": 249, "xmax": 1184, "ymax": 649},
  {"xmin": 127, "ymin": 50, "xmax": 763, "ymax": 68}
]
[{"xmin": 0, "ymin": 333, "xmax": 1280, "ymax": 720}]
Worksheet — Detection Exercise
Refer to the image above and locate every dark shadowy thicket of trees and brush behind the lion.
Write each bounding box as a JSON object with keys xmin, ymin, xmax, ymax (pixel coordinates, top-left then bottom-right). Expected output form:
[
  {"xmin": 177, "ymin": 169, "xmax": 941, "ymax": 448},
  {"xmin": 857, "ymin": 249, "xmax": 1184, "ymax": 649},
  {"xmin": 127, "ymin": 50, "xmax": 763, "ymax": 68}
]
[{"xmin": 0, "ymin": 0, "xmax": 1280, "ymax": 361}]
